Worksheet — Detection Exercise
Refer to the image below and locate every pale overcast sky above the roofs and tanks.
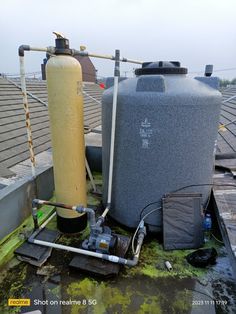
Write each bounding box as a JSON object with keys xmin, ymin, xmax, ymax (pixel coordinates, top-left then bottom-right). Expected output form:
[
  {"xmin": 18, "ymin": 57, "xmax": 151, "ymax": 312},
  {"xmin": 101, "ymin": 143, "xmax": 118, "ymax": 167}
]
[{"xmin": 0, "ymin": 0, "xmax": 236, "ymax": 79}]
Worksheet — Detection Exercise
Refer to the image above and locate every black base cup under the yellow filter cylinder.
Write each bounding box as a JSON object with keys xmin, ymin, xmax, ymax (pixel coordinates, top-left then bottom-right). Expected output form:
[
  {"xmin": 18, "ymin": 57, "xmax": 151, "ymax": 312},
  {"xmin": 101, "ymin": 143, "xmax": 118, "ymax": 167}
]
[{"xmin": 57, "ymin": 214, "xmax": 87, "ymax": 233}]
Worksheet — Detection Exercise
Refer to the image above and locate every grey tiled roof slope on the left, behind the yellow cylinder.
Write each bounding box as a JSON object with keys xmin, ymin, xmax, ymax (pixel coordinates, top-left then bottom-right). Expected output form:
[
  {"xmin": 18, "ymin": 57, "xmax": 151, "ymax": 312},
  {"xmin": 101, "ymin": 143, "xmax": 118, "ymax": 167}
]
[{"xmin": 0, "ymin": 78, "xmax": 102, "ymax": 177}]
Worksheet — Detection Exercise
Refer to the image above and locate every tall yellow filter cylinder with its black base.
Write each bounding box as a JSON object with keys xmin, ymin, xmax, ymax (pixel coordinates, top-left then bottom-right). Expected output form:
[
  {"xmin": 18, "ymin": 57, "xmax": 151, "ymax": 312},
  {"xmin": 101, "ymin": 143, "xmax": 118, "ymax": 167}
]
[{"xmin": 46, "ymin": 55, "xmax": 87, "ymax": 232}]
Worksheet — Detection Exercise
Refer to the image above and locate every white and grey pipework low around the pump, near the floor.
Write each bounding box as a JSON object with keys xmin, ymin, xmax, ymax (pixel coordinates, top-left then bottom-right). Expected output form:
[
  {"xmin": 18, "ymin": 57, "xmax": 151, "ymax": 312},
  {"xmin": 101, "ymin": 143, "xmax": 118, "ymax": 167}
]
[{"xmin": 28, "ymin": 199, "xmax": 146, "ymax": 267}]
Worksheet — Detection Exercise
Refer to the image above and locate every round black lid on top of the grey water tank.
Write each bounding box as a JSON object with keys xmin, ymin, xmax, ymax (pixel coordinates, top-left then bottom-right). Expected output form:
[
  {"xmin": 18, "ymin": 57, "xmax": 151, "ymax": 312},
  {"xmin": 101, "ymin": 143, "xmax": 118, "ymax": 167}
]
[{"xmin": 135, "ymin": 61, "xmax": 188, "ymax": 75}]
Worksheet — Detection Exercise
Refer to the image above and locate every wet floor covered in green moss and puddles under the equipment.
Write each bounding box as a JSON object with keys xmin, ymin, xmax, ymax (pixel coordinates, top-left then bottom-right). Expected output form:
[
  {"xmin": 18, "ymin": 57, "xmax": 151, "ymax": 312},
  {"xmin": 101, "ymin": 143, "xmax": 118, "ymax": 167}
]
[{"xmin": 0, "ymin": 175, "xmax": 236, "ymax": 314}]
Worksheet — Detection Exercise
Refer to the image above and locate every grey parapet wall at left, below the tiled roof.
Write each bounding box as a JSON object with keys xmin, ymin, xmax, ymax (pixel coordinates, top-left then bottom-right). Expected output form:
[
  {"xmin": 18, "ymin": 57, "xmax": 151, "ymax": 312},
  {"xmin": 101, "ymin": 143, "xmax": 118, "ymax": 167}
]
[{"xmin": 0, "ymin": 167, "xmax": 54, "ymax": 241}]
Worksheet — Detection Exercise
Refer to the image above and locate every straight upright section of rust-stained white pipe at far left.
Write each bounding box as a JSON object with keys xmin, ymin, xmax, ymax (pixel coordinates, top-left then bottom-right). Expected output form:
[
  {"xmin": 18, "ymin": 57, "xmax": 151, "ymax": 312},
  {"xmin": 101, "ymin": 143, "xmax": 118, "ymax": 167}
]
[{"xmin": 19, "ymin": 56, "xmax": 35, "ymax": 177}]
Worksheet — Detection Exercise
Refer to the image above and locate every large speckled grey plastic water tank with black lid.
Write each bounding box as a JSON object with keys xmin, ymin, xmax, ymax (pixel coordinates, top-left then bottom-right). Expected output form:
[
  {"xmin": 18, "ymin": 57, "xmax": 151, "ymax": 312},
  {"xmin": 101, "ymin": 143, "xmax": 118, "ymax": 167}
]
[{"xmin": 102, "ymin": 62, "xmax": 221, "ymax": 231}]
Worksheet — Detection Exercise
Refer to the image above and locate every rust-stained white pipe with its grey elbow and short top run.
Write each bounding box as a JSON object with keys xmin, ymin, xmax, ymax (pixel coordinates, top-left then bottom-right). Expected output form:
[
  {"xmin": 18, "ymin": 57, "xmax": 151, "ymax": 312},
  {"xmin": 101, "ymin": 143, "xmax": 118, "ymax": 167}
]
[{"xmin": 18, "ymin": 45, "xmax": 53, "ymax": 178}]
